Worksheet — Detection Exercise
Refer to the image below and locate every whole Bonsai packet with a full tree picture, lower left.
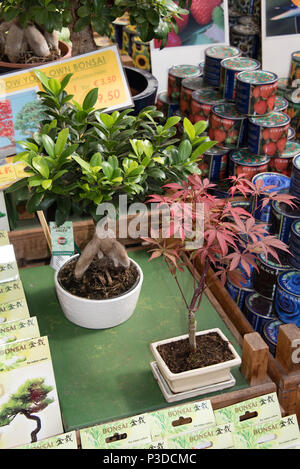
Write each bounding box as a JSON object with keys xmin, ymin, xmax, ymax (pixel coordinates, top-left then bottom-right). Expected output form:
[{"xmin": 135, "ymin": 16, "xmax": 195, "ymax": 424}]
[{"xmin": 0, "ymin": 336, "xmax": 63, "ymax": 449}]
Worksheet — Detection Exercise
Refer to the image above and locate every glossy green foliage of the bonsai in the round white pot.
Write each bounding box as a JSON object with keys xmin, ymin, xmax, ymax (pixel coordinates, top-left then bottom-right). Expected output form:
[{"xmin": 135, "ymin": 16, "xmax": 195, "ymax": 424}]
[{"xmin": 7, "ymin": 72, "xmax": 214, "ymax": 225}]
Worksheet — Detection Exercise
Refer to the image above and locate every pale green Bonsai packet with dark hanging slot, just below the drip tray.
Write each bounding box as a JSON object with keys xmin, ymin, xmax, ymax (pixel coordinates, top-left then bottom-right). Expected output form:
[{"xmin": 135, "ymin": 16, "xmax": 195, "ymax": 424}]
[{"xmin": 149, "ymin": 400, "xmax": 215, "ymax": 441}]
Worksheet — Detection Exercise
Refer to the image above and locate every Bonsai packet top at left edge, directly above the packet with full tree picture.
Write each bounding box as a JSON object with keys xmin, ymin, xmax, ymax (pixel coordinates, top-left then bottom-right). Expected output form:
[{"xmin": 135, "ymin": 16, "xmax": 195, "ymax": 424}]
[{"xmin": 0, "ymin": 316, "xmax": 40, "ymax": 345}]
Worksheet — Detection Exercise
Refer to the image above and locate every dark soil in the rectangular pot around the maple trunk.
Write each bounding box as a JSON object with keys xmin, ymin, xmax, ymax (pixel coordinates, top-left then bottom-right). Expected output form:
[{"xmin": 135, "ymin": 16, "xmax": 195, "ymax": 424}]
[{"xmin": 157, "ymin": 332, "xmax": 235, "ymax": 373}]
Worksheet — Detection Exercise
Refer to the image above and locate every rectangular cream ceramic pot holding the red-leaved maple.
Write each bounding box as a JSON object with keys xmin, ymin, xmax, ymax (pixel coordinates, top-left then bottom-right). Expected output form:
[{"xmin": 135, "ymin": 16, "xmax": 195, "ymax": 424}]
[{"xmin": 150, "ymin": 328, "xmax": 241, "ymax": 393}]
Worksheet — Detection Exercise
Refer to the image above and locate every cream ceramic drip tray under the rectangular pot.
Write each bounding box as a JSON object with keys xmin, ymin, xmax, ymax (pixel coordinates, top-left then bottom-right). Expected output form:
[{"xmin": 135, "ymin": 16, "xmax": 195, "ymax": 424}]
[{"xmin": 150, "ymin": 362, "xmax": 236, "ymax": 402}]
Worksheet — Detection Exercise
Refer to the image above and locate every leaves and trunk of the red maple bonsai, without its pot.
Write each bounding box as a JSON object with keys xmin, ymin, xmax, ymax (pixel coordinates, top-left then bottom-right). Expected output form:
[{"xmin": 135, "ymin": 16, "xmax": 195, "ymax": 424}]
[{"xmin": 147, "ymin": 171, "xmax": 293, "ymax": 352}]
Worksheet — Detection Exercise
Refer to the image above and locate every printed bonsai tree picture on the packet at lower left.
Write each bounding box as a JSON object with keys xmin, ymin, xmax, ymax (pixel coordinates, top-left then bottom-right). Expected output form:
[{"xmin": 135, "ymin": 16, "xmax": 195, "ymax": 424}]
[{"xmin": 0, "ymin": 378, "xmax": 53, "ymax": 443}]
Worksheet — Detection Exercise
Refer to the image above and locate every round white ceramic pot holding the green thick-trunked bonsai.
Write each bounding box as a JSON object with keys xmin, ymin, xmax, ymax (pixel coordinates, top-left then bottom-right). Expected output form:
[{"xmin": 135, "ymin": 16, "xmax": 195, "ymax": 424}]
[{"xmin": 54, "ymin": 254, "xmax": 143, "ymax": 329}]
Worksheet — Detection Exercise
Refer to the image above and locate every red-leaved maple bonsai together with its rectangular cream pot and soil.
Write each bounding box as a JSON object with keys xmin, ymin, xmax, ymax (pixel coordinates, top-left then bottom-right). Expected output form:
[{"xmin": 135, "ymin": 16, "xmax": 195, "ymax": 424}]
[{"xmin": 147, "ymin": 131, "xmax": 293, "ymax": 393}]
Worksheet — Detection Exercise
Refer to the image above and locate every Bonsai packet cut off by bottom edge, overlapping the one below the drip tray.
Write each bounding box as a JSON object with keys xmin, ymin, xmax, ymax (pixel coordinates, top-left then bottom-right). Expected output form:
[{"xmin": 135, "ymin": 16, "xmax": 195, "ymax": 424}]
[{"xmin": 167, "ymin": 423, "xmax": 234, "ymax": 449}]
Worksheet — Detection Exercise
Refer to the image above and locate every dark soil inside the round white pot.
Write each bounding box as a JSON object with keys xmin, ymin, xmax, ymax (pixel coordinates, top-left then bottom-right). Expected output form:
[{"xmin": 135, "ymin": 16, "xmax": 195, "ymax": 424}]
[{"xmin": 58, "ymin": 257, "xmax": 139, "ymax": 300}]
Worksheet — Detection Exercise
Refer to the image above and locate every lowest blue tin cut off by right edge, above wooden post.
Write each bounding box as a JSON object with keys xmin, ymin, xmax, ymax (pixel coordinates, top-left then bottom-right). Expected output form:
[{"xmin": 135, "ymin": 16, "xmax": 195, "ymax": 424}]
[{"xmin": 275, "ymin": 270, "xmax": 300, "ymax": 327}]
